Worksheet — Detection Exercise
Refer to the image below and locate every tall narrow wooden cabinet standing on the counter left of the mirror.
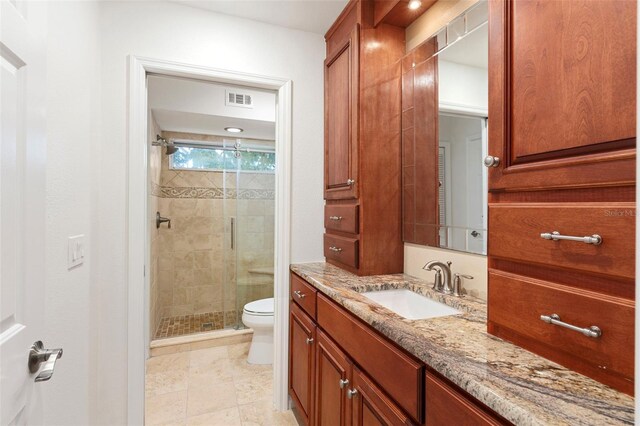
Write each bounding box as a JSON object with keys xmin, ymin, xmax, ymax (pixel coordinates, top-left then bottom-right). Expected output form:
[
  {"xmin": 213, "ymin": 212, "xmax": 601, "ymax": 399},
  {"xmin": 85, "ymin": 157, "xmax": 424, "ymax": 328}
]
[{"xmin": 324, "ymin": 0, "xmax": 405, "ymax": 275}]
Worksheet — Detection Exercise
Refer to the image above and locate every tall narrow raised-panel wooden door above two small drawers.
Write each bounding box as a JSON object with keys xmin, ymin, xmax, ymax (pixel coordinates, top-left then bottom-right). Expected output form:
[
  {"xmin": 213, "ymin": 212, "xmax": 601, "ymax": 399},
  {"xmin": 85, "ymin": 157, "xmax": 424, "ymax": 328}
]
[{"xmin": 324, "ymin": 25, "xmax": 359, "ymax": 200}]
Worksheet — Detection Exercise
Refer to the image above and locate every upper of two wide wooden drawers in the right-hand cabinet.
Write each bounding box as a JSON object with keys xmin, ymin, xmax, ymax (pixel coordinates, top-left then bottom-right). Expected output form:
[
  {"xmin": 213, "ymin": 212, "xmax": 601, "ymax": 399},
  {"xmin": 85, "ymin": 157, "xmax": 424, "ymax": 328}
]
[{"xmin": 488, "ymin": 203, "xmax": 635, "ymax": 279}]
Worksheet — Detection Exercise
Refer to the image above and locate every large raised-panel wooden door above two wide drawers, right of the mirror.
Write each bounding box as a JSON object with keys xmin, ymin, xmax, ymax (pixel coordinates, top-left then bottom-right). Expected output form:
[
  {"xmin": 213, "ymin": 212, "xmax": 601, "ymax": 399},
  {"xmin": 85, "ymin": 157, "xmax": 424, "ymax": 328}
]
[{"xmin": 489, "ymin": 0, "xmax": 637, "ymax": 191}]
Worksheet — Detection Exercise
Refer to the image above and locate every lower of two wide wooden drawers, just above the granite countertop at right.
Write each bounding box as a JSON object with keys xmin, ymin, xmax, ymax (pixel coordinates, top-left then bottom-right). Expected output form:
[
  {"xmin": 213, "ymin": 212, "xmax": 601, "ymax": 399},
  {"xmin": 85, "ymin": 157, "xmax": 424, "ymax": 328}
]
[{"xmin": 488, "ymin": 269, "xmax": 635, "ymax": 391}]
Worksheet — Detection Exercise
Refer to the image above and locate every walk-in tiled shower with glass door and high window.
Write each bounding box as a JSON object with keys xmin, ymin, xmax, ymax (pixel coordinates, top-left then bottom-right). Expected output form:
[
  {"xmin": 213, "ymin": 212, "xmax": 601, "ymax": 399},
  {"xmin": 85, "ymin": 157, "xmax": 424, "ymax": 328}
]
[{"xmin": 149, "ymin": 130, "xmax": 276, "ymax": 339}]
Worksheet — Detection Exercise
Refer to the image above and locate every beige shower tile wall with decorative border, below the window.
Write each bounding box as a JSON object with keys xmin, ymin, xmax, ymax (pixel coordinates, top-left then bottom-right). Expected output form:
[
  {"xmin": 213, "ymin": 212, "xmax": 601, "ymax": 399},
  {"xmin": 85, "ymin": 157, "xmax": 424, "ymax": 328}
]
[{"xmin": 157, "ymin": 132, "xmax": 275, "ymax": 330}]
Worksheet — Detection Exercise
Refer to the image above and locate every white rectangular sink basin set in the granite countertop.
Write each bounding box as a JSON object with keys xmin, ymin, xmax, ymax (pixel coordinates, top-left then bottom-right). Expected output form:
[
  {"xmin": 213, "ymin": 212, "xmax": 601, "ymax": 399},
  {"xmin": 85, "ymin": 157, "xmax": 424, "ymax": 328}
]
[{"xmin": 360, "ymin": 289, "xmax": 462, "ymax": 319}]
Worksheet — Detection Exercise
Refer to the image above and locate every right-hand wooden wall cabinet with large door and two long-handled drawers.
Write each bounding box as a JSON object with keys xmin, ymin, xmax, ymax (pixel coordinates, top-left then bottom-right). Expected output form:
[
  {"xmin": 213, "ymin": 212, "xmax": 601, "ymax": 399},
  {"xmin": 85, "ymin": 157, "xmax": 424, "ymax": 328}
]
[{"xmin": 487, "ymin": 0, "xmax": 637, "ymax": 394}]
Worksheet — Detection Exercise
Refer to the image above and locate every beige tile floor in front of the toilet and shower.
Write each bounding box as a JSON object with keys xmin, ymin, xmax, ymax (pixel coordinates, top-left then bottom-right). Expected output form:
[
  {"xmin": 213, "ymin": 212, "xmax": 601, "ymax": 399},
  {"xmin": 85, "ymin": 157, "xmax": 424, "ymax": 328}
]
[{"xmin": 145, "ymin": 343, "xmax": 298, "ymax": 426}]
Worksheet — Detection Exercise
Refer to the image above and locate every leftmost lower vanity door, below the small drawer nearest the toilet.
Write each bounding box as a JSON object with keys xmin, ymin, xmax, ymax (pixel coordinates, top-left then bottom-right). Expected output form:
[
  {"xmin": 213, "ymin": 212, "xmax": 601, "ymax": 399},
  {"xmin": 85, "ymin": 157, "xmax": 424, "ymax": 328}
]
[{"xmin": 289, "ymin": 303, "xmax": 316, "ymax": 425}]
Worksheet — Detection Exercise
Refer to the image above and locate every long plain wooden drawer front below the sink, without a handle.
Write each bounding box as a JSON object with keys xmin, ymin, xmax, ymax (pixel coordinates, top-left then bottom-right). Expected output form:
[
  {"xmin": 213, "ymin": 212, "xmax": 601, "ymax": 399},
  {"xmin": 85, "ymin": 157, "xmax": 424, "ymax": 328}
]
[{"xmin": 318, "ymin": 294, "xmax": 424, "ymax": 423}]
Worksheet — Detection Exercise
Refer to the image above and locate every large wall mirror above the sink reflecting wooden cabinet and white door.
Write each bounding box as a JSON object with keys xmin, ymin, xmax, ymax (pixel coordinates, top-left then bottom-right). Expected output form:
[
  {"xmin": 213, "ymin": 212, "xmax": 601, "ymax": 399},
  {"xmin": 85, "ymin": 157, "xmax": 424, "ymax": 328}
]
[{"xmin": 402, "ymin": 1, "xmax": 489, "ymax": 254}]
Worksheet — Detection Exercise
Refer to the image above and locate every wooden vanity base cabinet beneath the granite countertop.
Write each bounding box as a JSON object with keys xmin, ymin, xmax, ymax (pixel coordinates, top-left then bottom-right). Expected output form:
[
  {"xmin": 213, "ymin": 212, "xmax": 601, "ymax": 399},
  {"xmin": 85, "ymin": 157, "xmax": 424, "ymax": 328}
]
[{"xmin": 289, "ymin": 273, "xmax": 509, "ymax": 426}]
